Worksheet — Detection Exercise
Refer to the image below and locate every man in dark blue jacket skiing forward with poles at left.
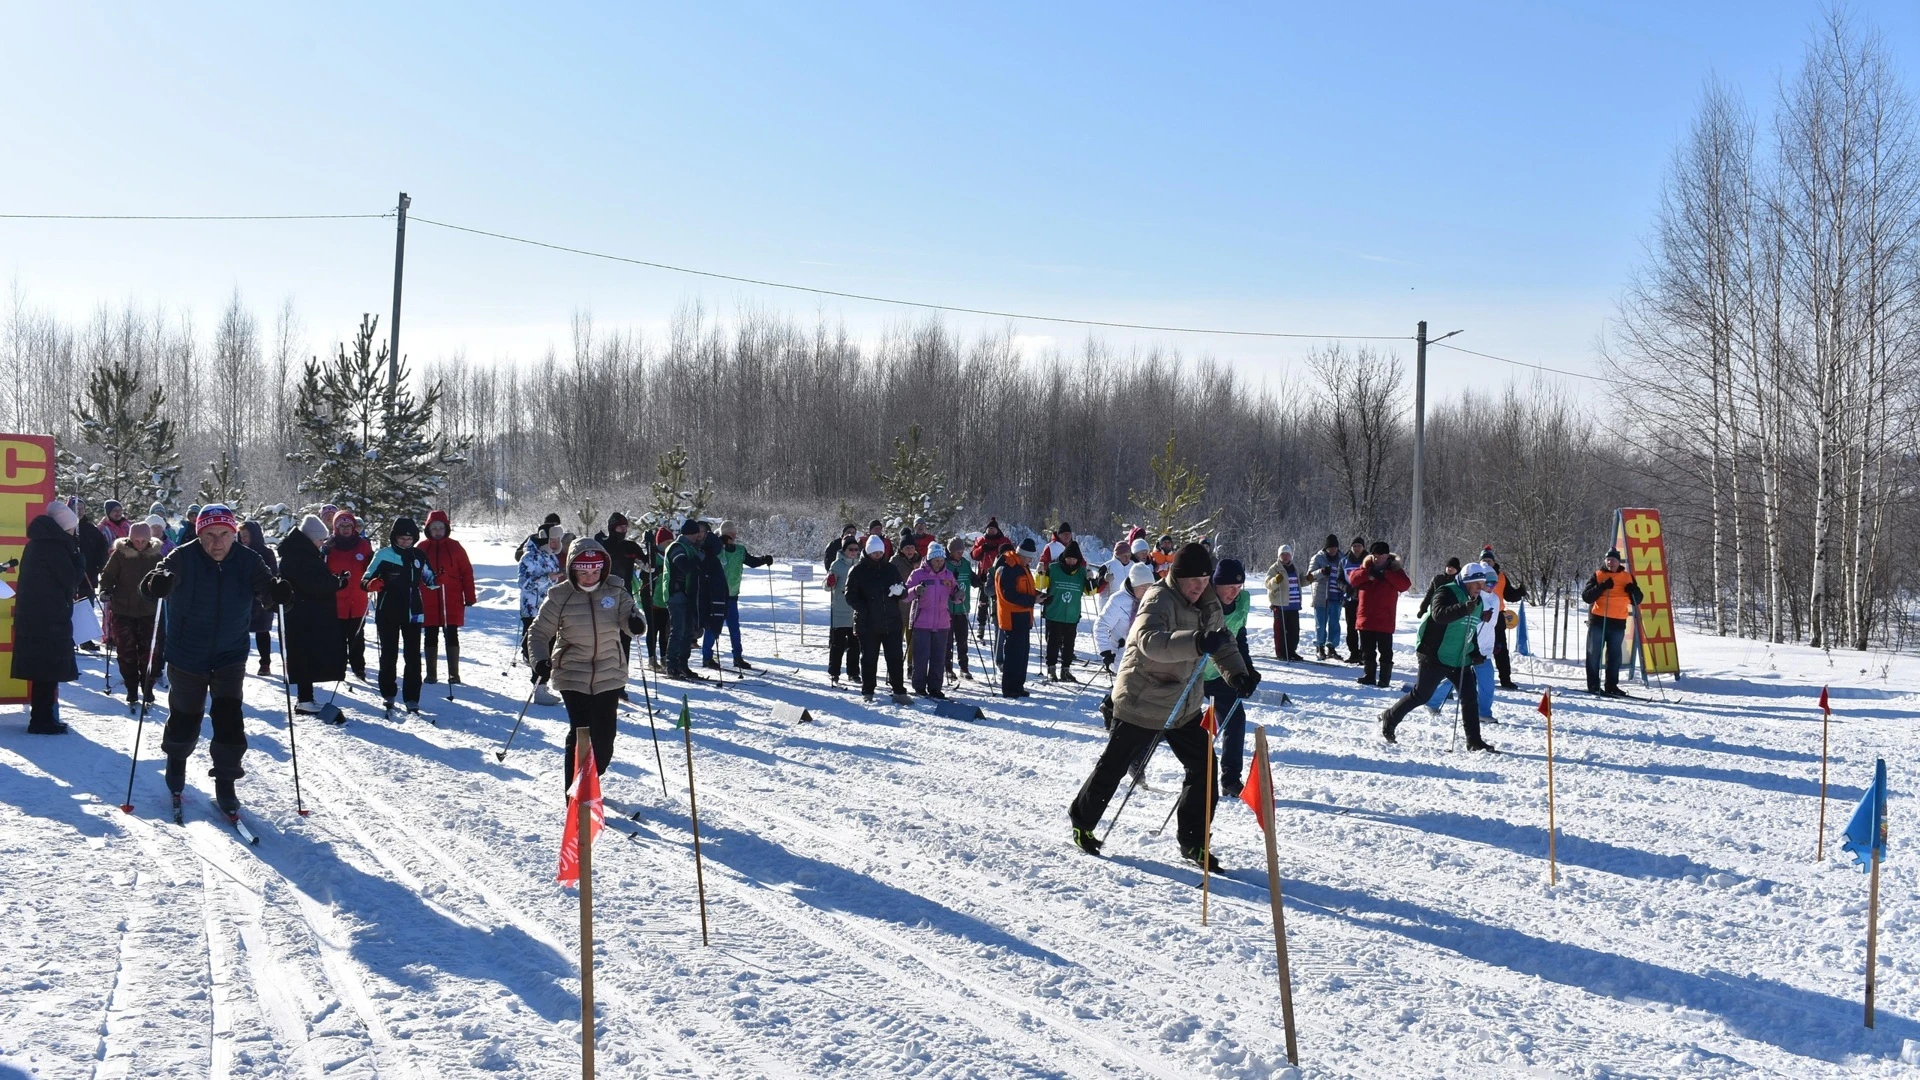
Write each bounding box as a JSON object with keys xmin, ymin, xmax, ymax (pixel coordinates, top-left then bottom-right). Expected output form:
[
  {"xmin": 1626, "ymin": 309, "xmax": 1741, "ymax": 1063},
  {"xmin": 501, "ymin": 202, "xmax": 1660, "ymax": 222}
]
[{"xmin": 140, "ymin": 503, "xmax": 294, "ymax": 813}]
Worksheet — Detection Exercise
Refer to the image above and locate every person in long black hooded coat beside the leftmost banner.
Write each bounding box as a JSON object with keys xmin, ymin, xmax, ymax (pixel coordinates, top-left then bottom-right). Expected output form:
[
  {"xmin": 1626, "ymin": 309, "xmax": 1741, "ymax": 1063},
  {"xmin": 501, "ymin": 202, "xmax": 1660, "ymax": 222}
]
[{"xmin": 12, "ymin": 500, "xmax": 88, "ymax": 734}]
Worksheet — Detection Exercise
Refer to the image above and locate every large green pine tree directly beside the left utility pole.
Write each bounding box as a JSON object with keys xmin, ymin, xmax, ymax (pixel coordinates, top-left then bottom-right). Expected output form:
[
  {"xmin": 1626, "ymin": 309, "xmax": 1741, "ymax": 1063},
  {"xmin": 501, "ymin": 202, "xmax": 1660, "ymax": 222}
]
[{"xmin": 288, "ymin": 315, "xmax": 467, "ymax": 523}]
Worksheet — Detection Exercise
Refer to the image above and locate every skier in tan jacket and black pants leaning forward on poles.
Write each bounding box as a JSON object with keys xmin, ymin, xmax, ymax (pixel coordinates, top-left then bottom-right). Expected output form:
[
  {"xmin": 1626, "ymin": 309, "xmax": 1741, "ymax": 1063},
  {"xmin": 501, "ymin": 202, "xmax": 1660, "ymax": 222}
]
[{"xmin": 1068, "ymin": 544, "xmax": 1260, "ymax": 872}]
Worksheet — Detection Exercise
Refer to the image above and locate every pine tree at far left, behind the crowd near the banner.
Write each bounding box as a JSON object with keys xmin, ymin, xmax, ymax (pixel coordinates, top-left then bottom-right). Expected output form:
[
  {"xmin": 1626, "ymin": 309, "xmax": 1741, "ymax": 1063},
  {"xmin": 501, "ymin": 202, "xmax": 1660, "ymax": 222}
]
[{"xmin": 56, "ymin": 363, "xmax": 180, "ymax": 517}]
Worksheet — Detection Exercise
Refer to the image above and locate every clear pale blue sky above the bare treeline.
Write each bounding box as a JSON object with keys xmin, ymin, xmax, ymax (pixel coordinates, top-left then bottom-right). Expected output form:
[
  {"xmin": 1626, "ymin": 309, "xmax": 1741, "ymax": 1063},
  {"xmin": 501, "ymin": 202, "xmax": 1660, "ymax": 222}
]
[{"xmin": 0, "ymin": 0, "xmax": 1920, "ymax": 392}]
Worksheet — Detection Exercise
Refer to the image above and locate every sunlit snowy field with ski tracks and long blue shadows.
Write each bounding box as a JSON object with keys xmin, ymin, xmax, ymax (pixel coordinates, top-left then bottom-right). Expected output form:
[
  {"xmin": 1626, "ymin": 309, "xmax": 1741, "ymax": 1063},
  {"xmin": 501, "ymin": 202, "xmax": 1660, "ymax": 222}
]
[{"xmin": 0, "ymin": 540, "xmax": 1920, "ymax": 1078}]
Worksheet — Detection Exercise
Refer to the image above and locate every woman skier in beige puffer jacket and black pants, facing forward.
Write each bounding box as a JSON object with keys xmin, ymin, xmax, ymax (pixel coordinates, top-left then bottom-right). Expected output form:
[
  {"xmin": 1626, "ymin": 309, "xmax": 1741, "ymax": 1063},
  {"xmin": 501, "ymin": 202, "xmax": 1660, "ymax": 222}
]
[{"xmin": 528, "ymin": 538, "xmax": 647, "ymax": 788}]
